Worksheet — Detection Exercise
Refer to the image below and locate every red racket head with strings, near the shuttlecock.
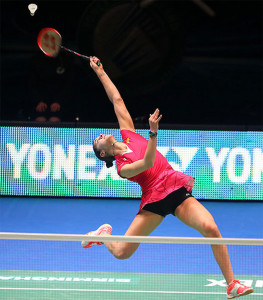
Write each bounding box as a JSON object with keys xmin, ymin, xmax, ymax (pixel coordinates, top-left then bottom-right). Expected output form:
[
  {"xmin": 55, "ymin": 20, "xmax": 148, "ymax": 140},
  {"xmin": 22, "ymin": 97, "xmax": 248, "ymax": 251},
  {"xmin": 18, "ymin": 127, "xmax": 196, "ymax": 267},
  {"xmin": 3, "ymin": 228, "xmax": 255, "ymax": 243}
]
[{"xmin": 37, "ymin": 27, "xmax": 62, "ymax": 57}]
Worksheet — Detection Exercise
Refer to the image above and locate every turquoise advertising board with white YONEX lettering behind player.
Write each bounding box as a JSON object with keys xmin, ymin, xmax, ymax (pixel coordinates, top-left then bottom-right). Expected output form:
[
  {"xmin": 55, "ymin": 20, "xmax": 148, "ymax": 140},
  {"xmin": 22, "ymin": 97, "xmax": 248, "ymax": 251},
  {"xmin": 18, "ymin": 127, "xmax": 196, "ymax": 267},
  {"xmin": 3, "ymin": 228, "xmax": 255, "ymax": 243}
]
[{"xmin": 0, "ymin": 126, "xmax": 263, "ymax": 200}]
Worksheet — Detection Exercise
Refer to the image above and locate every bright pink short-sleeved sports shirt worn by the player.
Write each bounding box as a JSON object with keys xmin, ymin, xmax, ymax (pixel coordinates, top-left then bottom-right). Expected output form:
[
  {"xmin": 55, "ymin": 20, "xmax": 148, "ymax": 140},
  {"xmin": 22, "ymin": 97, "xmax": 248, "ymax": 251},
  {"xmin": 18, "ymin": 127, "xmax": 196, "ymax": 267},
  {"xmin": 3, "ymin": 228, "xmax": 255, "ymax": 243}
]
[{"xmin": 115, "ymin": 130, "xmax": 194, "ymax": 211}]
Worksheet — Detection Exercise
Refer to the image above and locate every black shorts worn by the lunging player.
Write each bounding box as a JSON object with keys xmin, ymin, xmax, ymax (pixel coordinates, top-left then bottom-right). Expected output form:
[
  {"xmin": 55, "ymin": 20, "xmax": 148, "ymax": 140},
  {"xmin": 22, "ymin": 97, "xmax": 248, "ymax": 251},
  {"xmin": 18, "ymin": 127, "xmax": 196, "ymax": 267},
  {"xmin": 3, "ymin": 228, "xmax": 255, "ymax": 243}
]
[{"xmin": 143, "ymin": 187, "xmax": 193, "ymax": 217}]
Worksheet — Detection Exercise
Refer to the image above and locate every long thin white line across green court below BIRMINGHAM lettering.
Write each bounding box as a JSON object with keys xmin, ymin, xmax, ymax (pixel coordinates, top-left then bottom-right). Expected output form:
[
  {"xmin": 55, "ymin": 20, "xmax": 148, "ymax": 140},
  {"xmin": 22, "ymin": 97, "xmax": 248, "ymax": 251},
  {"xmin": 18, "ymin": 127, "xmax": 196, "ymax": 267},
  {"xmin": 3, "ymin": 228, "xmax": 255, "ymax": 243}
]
[{"xmin": 0, "ymin": 287, "xmax": 263, "ymax": 296}]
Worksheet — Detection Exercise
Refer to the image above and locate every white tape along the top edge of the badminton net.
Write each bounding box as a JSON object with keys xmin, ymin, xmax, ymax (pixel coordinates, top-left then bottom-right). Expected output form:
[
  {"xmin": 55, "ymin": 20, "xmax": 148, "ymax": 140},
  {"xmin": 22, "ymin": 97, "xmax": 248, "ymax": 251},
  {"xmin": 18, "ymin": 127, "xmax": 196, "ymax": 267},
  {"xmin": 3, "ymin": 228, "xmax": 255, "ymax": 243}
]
[{"xmin": 0, "ymin": 232, "xmax": 263, "ymax": 246}]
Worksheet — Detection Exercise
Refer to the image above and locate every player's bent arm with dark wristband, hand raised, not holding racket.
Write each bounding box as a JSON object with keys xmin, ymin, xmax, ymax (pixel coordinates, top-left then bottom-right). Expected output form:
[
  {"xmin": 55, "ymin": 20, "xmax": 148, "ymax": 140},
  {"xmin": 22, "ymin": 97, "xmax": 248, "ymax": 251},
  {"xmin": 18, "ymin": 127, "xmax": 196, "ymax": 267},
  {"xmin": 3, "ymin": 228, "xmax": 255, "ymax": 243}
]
[{"xmin": 120, "ymin": 108, "xmax": 162, "ymax": 178}]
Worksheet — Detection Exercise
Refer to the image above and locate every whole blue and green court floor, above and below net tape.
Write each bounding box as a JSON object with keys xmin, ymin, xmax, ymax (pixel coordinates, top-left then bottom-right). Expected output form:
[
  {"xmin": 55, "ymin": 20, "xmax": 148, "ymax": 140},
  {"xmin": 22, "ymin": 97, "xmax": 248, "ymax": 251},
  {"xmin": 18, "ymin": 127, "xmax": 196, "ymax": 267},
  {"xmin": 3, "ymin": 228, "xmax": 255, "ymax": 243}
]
[{"xmin": 0, "ymin": 197, "xmax": 263, "ymax": 300}]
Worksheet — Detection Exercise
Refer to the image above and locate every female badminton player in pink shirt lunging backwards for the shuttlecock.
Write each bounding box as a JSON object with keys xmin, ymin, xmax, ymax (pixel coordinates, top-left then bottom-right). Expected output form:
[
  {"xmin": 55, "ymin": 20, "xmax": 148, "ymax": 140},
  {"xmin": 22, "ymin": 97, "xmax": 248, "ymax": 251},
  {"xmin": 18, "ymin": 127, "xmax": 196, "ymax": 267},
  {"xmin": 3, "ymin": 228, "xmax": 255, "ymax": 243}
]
[{"xmin": 82, "ymin": 57, "xmax": 253, "ymax": 299}]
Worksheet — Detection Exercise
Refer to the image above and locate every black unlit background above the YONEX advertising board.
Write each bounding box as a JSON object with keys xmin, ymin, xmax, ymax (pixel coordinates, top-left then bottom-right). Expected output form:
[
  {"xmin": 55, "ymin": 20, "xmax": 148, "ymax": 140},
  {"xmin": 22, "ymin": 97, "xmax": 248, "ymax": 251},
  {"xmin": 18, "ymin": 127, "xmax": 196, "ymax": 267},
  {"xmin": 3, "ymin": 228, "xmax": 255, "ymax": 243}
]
[{"xmin": 0, "ymin": 0, "xmax": 263, "ymax": 125}]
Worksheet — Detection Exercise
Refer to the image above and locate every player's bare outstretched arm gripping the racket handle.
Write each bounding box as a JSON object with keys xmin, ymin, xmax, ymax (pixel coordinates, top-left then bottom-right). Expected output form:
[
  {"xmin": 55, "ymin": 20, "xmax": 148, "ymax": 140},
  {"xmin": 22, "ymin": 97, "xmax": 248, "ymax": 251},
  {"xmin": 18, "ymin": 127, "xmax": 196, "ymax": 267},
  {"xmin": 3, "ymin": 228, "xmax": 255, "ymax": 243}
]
[{"xmin": 90, "ymin": 57, "xmax": 135, "ymax": 131}]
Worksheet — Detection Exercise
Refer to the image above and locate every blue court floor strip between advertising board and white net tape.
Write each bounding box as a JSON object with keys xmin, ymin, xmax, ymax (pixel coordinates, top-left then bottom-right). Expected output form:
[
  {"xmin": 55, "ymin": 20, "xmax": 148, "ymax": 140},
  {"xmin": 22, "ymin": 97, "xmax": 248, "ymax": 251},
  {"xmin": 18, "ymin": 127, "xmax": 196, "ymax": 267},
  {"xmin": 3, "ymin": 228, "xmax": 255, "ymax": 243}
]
[{"xmin": 0, "ymin": 197, "xmax": 263, "ymax": 238}]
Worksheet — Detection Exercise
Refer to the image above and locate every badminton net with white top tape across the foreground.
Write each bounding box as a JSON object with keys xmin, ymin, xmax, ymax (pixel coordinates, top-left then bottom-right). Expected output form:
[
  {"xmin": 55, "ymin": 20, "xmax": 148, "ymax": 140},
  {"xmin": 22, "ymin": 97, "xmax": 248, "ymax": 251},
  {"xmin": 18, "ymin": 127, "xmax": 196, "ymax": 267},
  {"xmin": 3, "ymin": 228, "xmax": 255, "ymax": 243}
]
[{"xmin": 0, "ymin": 233, "xmax": 263, "ymax": 300}]
